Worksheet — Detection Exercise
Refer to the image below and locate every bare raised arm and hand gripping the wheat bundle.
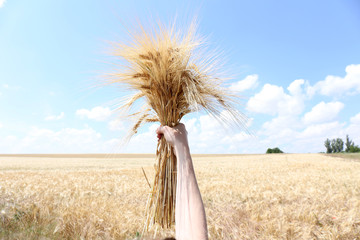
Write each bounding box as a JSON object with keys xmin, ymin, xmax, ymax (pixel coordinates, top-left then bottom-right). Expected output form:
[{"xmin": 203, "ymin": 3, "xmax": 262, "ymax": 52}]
[{"xmin": 156, "ymin": 124, "xmax": 208, "ymax": 240}]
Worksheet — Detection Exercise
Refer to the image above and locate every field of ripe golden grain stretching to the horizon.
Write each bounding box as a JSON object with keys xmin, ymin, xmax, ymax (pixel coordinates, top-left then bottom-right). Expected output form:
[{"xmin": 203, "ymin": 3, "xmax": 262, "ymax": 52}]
[{"xmin": 0, "ymin": 154, "xmax": 360, "ymax": 239}]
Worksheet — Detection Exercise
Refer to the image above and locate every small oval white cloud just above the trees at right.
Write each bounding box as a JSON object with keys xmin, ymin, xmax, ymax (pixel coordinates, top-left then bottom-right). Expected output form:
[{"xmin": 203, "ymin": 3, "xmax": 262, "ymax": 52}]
[{"xmin": 303, "ymin": 102, "xmax": 344, "ymax": 124}]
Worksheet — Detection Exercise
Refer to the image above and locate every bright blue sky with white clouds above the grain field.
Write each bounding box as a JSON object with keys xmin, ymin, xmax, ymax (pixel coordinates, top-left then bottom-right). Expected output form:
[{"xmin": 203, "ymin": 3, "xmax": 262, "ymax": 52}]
[{"xmin": 0, "ymin": 0, "xmax": 360, "ymax": 153}]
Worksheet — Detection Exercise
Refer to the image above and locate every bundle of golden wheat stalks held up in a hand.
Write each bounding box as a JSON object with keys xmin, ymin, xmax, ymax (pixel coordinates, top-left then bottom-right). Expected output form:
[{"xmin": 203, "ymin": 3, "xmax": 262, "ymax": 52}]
[{"xmin": 110, "ymin": 20, "xmax": 244, "ymax": 231}]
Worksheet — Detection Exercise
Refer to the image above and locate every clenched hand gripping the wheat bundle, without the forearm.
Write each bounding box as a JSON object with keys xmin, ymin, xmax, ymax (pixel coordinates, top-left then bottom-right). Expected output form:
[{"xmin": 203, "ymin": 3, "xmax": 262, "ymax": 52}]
[{"xmin": 156, "ymin": 123, "xmax": 187, "ymax": 147}]
